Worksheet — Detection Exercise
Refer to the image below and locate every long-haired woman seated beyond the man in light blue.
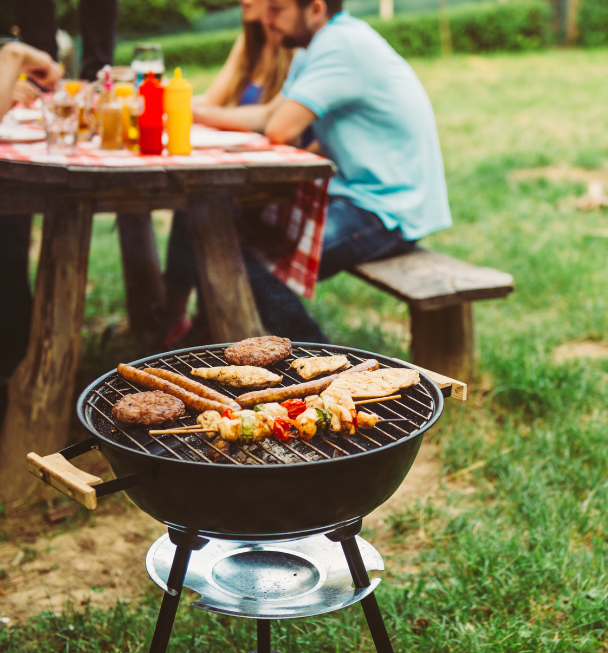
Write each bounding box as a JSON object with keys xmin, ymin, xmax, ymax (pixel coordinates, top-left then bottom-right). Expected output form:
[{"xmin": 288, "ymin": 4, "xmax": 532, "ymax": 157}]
[{"xmin": 162, "ymin": 0, "xmax": 293, "ymax": 347}]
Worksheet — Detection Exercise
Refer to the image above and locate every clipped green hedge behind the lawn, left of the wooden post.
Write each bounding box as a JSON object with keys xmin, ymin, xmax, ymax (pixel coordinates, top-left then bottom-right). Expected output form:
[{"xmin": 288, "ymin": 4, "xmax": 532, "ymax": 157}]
[{"xmin": 116, "ymin": 0, "xmax": 552, "ymax": 68}]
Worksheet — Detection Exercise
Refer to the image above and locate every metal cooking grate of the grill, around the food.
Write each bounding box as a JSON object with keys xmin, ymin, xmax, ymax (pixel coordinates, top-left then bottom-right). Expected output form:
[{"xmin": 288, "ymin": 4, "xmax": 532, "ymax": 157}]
[{"xmin": 85, "ymin": 345, "xmax": 436, "ymax": 465}]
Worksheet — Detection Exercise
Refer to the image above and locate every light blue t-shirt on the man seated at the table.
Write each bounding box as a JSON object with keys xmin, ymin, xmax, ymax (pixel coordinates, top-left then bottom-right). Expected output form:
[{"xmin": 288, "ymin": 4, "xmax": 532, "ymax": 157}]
[{"xmin": 282, "ymin": 11, "xmax": 452, "ymax": 240}]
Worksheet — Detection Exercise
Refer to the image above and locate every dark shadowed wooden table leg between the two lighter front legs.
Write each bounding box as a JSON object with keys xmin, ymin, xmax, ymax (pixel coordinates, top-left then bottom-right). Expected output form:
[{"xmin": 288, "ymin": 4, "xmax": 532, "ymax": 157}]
[{"xmin": 117, "ymin": 212, "xmax": 165, "ymax": 334}]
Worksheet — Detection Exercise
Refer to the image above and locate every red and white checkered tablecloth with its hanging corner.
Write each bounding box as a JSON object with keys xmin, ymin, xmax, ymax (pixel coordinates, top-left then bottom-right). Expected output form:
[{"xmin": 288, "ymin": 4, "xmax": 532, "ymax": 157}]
[{"xmin": 0, "ymin": 128, "xmax": 328, "ymax": 299}]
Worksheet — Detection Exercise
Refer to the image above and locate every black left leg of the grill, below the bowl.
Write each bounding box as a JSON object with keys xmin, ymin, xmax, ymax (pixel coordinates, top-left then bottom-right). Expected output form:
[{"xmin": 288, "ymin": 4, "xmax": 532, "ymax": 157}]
[{"xmin": 150, "ymin": 530, "xmax": 209, "ymax": 653}]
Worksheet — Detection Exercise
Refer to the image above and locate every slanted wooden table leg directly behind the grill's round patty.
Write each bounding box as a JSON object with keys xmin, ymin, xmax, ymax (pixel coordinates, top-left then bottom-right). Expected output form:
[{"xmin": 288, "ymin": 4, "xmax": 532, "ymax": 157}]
[{"xmin": 189, "ymin": 193, "xmax": 266, "ymax": 343}]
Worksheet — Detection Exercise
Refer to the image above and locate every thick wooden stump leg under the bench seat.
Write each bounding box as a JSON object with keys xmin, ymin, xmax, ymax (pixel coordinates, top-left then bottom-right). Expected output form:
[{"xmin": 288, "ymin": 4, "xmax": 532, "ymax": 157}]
[{"xmin": 410, "ymin": 302, "xmax": 475, "ymax": 382}]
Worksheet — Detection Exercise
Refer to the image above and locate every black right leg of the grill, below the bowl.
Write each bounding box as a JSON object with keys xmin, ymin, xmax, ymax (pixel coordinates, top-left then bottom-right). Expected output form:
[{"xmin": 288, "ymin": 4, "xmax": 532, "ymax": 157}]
[{"xmin": 327, "ymin": 521, "xmax": 394, "ymax": 653}]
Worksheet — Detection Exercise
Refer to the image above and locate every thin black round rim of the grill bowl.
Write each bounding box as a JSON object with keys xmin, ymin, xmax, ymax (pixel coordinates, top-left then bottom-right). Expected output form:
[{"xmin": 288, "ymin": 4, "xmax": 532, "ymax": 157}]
[{"xmin": 76, "ymin": 342, "xmax": 444, "ymax": 473}]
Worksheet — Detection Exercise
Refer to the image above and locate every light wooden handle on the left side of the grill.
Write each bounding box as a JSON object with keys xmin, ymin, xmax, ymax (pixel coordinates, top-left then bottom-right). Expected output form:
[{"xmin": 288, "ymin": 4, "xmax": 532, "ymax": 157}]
[{"xmin": 27, "ymin": 452, "xmax": 101, "ymax": 510}]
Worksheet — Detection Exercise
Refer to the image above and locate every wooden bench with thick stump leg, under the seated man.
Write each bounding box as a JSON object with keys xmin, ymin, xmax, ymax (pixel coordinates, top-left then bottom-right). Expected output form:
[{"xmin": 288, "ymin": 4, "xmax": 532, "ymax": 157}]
[{"xmin": 352, "ymin": 248, "xmax": 513, "ymax": 380}]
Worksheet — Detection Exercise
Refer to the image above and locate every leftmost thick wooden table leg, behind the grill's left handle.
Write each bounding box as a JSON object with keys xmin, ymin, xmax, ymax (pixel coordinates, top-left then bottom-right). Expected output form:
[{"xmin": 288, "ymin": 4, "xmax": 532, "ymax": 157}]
[{"xmin": 0, "ymin": 200, "xmax": 93, "ymax": 503}]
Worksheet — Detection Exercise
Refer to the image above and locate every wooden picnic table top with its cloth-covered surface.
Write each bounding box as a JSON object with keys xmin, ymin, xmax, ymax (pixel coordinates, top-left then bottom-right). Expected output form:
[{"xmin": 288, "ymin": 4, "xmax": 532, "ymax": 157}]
[{"xmin": 0, "ymin": 130, "xmax": 335, "ymax": 191}]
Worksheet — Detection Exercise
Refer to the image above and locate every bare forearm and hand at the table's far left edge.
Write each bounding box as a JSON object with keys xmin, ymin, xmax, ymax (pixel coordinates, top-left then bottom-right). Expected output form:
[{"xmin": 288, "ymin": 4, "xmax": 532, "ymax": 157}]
[{"xmin": 0, "ymin": 43, "xmax": 63, "ymax": 119}]
